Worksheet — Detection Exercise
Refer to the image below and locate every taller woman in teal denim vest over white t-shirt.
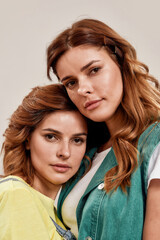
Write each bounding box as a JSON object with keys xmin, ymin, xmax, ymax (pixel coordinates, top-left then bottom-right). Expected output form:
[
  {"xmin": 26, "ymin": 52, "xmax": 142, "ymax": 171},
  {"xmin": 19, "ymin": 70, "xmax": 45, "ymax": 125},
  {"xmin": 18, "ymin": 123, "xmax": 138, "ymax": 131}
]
[{"xmin": 47, "ymin": 19, "xmax": 160, "ymax": 240}]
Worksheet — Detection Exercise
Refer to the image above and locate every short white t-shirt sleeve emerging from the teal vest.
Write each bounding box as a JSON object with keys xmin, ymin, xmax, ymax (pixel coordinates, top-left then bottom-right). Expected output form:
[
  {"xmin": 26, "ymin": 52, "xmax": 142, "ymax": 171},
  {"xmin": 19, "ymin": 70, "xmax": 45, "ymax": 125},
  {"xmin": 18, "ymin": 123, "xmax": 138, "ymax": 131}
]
[{"xmin": 148, "ymin": 143, "xmax": 160, "ymax": 187}]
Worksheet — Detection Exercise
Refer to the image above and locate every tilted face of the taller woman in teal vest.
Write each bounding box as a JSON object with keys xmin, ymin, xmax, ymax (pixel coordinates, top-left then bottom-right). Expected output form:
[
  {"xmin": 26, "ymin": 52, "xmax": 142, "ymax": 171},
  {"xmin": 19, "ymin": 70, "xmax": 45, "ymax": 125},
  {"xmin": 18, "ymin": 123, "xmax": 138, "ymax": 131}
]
[{"xmin": 56, "ymin": 45, "xmax": 123, "ymax": 122}]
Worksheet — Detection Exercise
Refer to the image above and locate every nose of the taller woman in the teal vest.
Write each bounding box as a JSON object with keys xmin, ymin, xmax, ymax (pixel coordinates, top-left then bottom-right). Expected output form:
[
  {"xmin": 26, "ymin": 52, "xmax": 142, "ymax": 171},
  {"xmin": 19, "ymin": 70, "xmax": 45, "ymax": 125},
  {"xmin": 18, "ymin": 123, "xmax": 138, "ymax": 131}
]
[{"xmin": 78, "ymin": 78, "xmax": 93, "ymax": 96}]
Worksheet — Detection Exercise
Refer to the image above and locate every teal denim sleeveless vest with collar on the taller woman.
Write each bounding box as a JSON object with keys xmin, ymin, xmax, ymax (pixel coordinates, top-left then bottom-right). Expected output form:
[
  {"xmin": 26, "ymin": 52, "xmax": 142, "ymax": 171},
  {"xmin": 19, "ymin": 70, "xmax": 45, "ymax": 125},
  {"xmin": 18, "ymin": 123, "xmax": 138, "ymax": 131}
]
[{"xmin": 58, "ymin": 123, "xmax": 160, "ymax": 240}]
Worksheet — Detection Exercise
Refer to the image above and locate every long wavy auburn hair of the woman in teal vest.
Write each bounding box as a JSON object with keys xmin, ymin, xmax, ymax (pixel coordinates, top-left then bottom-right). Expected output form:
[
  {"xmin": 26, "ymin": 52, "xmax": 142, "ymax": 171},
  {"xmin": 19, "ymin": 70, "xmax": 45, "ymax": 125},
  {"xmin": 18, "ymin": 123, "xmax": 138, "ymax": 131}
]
[{"xmin": 47, "ymin": 19, "xmax": 160, "ymax": 192}]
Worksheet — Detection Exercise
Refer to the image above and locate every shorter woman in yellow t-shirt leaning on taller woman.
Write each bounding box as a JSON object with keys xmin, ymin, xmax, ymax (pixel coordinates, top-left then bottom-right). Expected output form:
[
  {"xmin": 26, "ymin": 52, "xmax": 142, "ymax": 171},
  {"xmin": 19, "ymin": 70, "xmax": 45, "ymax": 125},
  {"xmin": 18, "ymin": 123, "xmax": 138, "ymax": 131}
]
[{"xmin": 0, "ymin": 84, "xmax": 92, "ymax": 240}]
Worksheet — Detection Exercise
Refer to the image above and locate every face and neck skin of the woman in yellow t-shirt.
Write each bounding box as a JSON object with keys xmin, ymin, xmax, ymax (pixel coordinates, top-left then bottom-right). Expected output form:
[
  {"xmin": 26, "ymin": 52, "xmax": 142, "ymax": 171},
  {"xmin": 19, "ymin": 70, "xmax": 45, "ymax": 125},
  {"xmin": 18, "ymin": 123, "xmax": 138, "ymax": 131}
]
[{"xmin": 26, "ymin": 111, "xmax": 87, "ymax": 199}]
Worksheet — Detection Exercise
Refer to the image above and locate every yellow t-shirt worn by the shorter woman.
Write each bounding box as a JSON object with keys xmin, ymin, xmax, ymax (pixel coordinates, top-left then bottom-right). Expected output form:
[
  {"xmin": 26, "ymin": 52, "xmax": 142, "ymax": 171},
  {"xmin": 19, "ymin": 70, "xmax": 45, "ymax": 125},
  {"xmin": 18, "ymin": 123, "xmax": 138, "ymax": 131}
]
[{"xmin": 0, "ymin": 176, "xmax": 65, "ymax": 240}]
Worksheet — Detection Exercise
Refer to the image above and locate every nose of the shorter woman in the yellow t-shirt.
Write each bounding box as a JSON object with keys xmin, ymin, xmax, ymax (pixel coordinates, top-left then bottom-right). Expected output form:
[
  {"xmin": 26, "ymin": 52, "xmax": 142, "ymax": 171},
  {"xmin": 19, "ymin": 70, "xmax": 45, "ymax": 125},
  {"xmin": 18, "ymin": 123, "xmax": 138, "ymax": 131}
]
[{"xmin": 57, "ymin": 142, "xmax": 71, "ymax": 160}]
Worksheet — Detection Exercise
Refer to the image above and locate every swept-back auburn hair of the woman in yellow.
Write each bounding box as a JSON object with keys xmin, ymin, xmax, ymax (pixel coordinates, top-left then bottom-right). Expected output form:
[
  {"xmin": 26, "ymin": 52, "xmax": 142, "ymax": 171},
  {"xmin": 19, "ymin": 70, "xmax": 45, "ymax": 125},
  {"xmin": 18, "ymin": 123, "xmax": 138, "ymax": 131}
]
[{"xmin": 2, "ymin": 84, "xmax": 77, "ymax": 184}]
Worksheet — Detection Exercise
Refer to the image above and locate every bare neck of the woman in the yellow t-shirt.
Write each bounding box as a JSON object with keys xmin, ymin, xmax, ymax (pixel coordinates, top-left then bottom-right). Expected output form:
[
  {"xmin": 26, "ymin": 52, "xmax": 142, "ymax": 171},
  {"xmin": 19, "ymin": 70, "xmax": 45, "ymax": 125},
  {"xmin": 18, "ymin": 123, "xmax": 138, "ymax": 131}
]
[{"xmin": 32, "ymin": 175, "xmax": 61, "ymax": 200}]
